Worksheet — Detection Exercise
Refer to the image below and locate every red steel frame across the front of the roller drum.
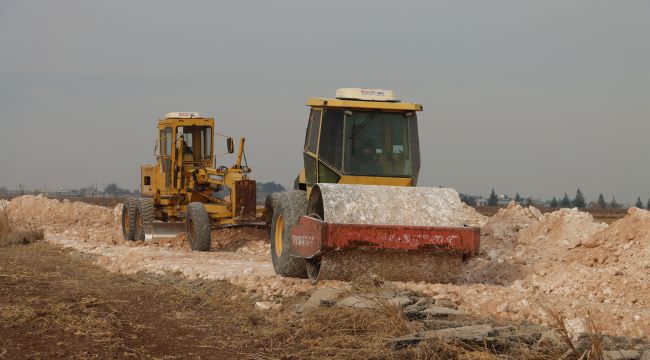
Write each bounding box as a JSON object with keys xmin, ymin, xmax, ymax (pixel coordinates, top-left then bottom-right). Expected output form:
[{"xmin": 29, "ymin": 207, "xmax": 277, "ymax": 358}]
[{"xmin": 290, "ymin": 216, "xmax": 481, "ymax": 258}]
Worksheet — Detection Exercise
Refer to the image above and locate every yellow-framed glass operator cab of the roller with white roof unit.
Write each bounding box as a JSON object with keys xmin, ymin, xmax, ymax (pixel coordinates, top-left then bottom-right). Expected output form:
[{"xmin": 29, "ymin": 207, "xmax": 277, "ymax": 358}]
[{"xmin": 299, "ymin": 88, "xmax": 422, "ymax": 188}]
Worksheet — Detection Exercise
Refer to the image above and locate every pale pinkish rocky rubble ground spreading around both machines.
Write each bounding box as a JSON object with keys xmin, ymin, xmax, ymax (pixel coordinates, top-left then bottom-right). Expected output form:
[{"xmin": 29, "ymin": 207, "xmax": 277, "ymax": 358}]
[{"xmin": 0, "ymin": 196, "xmax": 650, "ymax": 358}]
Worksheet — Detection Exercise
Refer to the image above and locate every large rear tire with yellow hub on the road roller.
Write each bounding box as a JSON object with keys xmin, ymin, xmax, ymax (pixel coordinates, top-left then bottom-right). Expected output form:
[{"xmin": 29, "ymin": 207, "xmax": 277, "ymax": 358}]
[{"xmin": 270, "ymin": 190, "xmax": 307, "ymax": 279}]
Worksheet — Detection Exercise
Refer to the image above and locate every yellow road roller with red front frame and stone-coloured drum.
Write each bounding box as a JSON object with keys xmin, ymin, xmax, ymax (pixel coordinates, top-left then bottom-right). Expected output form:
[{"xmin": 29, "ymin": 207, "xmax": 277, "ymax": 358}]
[{"xmin": 266, "ymin": 88, "xmax": 480, "ymax": 282}]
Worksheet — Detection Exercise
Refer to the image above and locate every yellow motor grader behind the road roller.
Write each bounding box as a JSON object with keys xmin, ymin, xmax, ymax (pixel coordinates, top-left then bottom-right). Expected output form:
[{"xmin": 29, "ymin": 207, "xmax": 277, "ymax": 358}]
[{"xmin": 122, "ymin": 112, "xmax": 264, "ymax": 251}]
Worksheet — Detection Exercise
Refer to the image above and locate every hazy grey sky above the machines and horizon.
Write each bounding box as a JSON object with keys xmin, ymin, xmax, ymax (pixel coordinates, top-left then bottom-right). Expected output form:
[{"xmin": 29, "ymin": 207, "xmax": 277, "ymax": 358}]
[{"xmin": 0, "ymin": 0, "xmax": 650, "ymax": 202}]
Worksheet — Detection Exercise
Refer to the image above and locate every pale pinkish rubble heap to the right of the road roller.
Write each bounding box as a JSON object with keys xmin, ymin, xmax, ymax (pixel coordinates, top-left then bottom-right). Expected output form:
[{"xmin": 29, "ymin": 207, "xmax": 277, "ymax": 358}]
[{"xmin": 446, "ymin": 204, "xmax": 650, "ymax": 336}]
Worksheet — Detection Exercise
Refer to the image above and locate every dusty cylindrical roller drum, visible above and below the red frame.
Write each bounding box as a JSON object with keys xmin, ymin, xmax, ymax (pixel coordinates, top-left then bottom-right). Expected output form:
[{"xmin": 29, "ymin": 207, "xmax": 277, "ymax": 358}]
[{"xmin": 308, "ymin": 184, "xmax": 466, "ymax": 283}]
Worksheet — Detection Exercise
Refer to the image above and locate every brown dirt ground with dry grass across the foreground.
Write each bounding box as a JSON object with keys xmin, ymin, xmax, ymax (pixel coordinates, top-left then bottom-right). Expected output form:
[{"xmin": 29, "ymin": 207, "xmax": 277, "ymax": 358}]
[{"xmin": 0, "ymin": 242, "xmax": 572, "ymax": 359}]
